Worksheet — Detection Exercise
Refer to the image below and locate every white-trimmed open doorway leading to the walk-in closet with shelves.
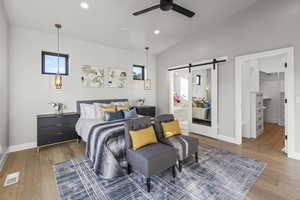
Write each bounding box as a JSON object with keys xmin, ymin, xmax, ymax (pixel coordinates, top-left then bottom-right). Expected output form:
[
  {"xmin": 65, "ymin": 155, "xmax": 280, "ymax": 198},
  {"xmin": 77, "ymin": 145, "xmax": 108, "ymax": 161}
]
[{"xmin": 236, "ymin": 48, "xmax": 295, "ymax": 156}]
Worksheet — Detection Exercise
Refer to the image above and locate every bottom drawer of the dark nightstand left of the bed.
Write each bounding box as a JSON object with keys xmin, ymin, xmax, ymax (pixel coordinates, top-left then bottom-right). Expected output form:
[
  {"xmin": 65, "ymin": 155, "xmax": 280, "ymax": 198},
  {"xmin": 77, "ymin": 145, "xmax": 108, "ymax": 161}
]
[{"xmin": 38, "ymin": 128, "xmax": 77, "ymax": 146}]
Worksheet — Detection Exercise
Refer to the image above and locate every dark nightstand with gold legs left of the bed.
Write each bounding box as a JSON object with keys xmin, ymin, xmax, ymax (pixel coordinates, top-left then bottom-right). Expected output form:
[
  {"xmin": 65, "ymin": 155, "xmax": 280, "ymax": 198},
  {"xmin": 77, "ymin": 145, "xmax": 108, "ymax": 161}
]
[{"xmin": 37, "ymin": 113, "xmax": 79, "ymax": 152}]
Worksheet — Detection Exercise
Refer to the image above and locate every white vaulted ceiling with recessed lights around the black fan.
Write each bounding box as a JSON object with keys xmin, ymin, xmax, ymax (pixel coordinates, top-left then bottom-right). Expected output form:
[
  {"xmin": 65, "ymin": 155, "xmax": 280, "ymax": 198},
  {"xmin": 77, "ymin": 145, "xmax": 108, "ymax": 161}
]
[{"xmin": 4, "ymin": 0, "xmax": 257, "ymax": 54}]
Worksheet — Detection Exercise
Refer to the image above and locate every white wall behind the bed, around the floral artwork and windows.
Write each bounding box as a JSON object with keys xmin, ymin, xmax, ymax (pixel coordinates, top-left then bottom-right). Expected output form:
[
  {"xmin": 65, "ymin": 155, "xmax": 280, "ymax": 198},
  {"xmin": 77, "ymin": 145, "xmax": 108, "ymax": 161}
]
[{"xmin": 9, "ymin": 27, "xmax": 156, "ymax": 145}]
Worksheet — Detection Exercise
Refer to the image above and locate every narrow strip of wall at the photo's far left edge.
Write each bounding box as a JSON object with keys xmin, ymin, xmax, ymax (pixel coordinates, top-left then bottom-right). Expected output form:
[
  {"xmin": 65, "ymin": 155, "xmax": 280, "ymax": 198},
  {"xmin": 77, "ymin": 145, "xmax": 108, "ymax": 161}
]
[{"xmin": 0, "ymin": 1, "xmax": 8, "ymax": 161}]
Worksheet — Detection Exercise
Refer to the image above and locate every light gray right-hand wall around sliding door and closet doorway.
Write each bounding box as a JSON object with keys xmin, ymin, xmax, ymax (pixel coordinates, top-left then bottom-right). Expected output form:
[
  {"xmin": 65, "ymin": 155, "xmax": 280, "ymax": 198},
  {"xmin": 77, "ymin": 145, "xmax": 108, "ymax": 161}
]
[{"xmin": 157, "ymin": 0, "xmax": 300, "ymax": 153}]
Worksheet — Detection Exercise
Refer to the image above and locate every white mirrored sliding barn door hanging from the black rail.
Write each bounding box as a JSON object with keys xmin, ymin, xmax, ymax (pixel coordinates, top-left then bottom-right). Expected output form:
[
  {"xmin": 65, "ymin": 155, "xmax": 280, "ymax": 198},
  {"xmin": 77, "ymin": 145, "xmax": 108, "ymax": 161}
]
[{"xmin": 189, "ymin": 65, "xmax": 218, "ymax": 138}]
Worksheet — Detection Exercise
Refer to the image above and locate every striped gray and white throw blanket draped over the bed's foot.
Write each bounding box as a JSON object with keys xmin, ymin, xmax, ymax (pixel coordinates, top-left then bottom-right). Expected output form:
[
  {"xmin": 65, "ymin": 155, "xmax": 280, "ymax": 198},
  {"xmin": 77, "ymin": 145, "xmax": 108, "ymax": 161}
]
[{"xmin": 86, "ymin": 120, "xmax": 127, "ymax": 179}]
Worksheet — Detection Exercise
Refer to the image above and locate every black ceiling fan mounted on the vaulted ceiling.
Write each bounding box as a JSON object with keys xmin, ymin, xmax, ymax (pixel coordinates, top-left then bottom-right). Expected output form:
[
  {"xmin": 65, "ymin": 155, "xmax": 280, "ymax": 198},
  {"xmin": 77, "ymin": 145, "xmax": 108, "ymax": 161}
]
[{"xmin": 133, "ymin": 0, "xmax": 195, "ymax": 17}]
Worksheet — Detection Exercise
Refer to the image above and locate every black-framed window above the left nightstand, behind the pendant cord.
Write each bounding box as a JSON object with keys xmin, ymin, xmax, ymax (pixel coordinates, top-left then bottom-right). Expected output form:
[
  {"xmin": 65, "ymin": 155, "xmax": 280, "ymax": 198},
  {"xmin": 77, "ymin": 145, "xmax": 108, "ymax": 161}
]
[{"xmin": 42, "ymin": 51, "xmax": 69, "ymax": 75}]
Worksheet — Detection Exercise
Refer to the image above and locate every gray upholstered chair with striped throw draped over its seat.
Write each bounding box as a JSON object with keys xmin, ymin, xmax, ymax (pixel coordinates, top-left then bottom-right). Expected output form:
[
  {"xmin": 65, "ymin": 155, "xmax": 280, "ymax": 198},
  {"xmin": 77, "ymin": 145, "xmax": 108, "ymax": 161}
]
[{"xmin": 155, "ymin": 114, "xmax": 199, "ymax": 172}]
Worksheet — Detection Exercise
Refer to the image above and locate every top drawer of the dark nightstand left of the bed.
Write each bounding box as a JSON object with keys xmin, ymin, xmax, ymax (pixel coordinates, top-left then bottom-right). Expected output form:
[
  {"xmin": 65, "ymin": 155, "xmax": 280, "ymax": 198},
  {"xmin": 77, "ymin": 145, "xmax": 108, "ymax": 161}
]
[{"xmin": 38, "ymin": 116, "xmax": 78, "ymax": 128}]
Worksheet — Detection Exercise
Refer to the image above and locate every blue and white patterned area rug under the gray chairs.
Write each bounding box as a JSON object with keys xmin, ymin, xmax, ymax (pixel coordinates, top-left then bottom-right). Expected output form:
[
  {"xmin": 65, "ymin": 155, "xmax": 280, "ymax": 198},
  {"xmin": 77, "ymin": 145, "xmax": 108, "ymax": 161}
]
[{"xmin": 53, "ymin": 144, "xmax": 267, "ymax": 200}]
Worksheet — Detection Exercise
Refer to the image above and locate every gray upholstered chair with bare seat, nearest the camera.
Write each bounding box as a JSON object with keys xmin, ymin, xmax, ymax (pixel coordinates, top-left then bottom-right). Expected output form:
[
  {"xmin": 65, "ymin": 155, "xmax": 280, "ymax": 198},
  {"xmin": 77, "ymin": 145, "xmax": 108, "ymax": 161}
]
[{"xmin": 125, "ymin": 117, "xmax": 177, "ymax": 192}]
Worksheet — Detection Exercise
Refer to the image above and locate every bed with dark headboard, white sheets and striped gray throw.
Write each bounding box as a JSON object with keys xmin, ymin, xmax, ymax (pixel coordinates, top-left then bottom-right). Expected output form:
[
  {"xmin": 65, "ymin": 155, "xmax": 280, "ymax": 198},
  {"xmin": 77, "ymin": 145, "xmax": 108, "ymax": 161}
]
[{"xmin": 76, "ymin": 99, "xmax": 128, "ymax": 179}]
